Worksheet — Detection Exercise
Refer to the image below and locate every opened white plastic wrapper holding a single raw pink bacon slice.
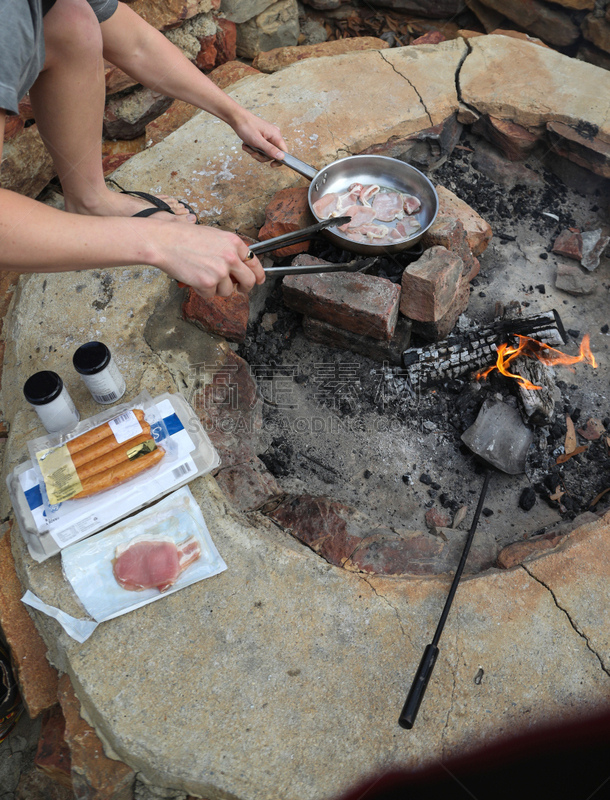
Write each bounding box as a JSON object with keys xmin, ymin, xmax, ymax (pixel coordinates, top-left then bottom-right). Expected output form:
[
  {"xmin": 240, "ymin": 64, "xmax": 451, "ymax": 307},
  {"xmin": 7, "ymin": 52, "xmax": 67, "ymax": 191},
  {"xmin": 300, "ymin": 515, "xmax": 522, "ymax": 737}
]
[{"xmin": 22, "ymin": 486, "xmax": 227, "ymax": 642}]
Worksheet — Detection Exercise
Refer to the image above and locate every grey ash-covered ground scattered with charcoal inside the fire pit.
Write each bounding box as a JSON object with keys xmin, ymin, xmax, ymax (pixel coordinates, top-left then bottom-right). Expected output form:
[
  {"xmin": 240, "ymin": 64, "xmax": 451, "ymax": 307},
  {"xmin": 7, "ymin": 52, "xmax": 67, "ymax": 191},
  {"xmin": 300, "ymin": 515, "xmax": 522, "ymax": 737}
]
[{"xmin": 238, "ymin": 134, "xmax": 610, "ymax": 546}]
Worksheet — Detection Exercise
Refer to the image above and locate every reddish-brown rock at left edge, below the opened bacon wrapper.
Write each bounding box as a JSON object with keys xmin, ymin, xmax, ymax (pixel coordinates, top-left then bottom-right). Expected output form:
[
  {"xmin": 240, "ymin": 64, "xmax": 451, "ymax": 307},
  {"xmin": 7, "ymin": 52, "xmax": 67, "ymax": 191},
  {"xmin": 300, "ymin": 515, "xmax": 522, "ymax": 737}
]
[{"xmin": 0, "ymin": 522, "xmax": 57, "ymax": 719}]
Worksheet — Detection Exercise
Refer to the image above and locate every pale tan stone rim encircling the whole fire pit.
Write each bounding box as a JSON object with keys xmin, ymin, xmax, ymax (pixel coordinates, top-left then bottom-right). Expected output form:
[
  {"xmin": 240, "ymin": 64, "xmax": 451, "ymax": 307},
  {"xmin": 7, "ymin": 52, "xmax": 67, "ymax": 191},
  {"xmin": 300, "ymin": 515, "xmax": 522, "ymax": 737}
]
[{"xmin": 2, "ymin": 36, "xmax": 610, "ymax": 800}]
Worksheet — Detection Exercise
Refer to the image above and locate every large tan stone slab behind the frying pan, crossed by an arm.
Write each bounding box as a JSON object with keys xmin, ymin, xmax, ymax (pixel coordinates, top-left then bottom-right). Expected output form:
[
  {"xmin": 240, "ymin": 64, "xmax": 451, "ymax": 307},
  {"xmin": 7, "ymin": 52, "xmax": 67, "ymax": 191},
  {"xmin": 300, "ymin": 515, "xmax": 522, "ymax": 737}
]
[{"xmin": 111, "ymin": 39, "xmax": 467, "ymax": 234}]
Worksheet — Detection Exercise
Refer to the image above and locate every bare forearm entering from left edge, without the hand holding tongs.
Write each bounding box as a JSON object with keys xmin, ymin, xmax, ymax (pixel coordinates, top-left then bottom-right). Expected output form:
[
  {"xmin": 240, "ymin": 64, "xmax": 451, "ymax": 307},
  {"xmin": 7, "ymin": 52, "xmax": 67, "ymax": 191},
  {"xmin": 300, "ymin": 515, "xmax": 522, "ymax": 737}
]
[{"xmin": 0, "ymin": 189, "xmax": 157, "ymax": 272}]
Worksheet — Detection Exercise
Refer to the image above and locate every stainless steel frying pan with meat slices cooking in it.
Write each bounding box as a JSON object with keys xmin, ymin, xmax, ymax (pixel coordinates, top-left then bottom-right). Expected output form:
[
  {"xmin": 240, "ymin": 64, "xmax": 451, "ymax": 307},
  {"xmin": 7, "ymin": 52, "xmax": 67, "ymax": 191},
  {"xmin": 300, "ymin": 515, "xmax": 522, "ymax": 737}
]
[{"xmin": 259, "ymin": 151, "xmax": 438, "ymax": 256}]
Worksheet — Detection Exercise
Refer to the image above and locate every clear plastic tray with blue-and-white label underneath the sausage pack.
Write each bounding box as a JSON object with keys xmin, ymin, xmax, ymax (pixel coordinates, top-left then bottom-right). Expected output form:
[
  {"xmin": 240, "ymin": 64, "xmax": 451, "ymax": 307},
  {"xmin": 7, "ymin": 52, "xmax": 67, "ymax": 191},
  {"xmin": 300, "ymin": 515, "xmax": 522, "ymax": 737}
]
[{"xmin": 7, "ymin": 393, "xmax": 220, "ymax": 562}]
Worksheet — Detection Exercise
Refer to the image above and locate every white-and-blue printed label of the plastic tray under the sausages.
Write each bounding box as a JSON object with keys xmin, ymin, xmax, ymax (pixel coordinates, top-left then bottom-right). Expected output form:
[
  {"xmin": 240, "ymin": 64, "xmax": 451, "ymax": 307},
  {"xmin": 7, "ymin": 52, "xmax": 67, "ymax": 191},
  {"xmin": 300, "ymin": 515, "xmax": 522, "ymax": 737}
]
[{"xmin": 19, "ymin": 399, "xmax": 197, "ymax": 548}]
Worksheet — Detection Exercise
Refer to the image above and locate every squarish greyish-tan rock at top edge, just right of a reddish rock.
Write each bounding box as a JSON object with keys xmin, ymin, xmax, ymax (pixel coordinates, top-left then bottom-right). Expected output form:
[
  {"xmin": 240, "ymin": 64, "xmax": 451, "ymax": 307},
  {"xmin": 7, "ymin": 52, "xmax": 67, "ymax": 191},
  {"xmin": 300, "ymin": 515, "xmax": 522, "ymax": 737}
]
[{"xmin": 237, "ymin": 0, "xmax": 299, "ymax": 58}]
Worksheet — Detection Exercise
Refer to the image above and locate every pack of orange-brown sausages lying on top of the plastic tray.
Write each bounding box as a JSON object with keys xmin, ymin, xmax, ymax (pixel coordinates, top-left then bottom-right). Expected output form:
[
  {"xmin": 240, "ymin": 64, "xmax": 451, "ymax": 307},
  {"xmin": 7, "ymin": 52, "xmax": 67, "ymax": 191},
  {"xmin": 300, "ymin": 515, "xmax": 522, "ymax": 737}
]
[{"xmin": 29, "ymin": 392, "xmax": 175, "ymax": 513}]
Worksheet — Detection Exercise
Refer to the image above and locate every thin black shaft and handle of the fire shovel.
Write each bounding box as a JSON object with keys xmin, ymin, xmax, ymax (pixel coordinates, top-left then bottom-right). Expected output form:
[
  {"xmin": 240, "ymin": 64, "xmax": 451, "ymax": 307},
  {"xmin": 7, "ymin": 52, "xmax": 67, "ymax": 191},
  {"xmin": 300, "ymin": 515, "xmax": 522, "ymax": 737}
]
[{"xmin": 398, "ymin": 469, "xmax": 491, "ymax": 730}]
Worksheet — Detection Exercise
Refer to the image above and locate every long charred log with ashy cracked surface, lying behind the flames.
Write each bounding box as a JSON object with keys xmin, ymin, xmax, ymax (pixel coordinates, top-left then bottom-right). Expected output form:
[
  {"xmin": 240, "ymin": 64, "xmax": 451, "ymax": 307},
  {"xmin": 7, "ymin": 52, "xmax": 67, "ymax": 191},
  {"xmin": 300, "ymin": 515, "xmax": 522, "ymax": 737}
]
[{"xmin": 402, "ymin": 309, "xmax": 568, "ymax": 388}]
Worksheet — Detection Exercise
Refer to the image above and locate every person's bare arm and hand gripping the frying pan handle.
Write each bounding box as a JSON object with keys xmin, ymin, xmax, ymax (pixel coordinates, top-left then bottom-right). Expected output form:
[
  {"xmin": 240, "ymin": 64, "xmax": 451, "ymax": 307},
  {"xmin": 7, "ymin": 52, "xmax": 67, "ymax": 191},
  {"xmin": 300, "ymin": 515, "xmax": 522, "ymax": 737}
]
[{"xmin": 100, "ymin": 3, "xmax": 287, "ymax": 161}]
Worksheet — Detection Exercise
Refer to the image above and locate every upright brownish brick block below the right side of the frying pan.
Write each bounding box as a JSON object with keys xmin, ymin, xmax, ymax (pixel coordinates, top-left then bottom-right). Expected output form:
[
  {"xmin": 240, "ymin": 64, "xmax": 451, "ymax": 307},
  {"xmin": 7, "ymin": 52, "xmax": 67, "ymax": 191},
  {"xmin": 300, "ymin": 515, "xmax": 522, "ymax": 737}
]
[{"xmin": 400, "ymin": 245, "xmax": 463, "ymax": 322}]
